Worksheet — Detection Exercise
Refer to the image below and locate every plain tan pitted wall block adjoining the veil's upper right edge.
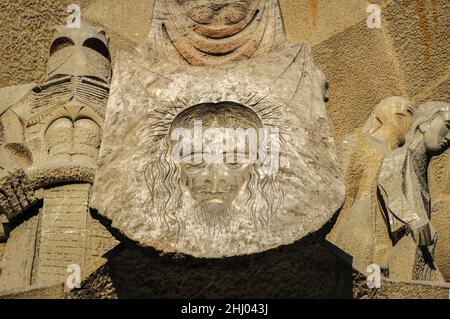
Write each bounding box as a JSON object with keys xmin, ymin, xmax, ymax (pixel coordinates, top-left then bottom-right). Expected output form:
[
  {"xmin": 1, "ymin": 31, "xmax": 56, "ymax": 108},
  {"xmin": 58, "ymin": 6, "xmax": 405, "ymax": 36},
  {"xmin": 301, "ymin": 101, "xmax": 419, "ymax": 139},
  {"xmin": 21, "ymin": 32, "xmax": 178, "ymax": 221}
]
[{"xmin": 313, "ymin": 20, "xmax": 407, "ymax": 142}]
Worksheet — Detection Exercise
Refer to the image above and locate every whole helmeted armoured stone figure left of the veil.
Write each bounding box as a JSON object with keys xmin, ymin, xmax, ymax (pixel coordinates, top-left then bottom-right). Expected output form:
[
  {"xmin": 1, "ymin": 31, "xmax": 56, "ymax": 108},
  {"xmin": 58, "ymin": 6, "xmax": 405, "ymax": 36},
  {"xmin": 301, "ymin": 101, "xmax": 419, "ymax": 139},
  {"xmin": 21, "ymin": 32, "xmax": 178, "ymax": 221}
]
[{"xmin": 0, "ymin": 18, "xmax": 115, "ymax": 290}]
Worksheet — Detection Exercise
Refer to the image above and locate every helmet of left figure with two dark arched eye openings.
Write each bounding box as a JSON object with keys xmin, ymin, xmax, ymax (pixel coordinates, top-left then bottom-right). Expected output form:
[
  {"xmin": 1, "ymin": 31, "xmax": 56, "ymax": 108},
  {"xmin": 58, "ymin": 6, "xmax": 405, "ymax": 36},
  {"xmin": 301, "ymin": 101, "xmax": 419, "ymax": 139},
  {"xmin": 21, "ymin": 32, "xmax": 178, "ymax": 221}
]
[{"xmin": 46, "ymin": 21, "xmax": 112, "ymax": 83}]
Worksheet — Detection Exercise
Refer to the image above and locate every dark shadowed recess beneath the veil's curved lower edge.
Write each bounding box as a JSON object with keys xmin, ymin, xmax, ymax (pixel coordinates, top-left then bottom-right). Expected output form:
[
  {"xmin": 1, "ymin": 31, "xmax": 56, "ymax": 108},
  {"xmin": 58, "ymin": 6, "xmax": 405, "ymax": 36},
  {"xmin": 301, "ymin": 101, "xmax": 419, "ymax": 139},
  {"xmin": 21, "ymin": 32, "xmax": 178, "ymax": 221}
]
[{"xmin": 65, "ymin": 228, "xmax": 352, "ymax": 299}]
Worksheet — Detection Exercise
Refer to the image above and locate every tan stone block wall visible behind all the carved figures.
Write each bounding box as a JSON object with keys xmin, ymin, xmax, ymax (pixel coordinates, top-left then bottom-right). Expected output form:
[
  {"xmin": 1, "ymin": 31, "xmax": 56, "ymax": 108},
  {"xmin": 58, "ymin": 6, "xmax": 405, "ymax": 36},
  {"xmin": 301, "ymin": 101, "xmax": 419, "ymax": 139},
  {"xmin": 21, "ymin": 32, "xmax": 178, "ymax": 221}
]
[{"xmin": 0, "ymin": 0, "xmax": 450, "ymax": 280}]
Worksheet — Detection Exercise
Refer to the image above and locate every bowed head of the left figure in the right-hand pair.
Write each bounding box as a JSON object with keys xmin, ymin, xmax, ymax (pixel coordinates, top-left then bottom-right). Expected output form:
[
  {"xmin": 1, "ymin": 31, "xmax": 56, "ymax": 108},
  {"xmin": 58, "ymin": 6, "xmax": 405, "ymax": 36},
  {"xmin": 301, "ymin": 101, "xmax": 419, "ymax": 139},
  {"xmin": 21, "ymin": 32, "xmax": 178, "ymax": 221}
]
[{"xmin": 363, "ymin": 96, "xmax": 413, "ymax": 149}]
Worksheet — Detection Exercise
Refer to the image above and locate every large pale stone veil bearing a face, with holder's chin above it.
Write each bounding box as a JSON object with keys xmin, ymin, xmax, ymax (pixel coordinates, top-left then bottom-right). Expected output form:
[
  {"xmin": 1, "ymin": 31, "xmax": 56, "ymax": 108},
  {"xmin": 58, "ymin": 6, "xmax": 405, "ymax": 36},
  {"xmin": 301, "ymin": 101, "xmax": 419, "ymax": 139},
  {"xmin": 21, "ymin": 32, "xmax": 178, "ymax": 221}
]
[{"xmin": 91, "ymin": 0, "xmax": 345, "ymax": 258}]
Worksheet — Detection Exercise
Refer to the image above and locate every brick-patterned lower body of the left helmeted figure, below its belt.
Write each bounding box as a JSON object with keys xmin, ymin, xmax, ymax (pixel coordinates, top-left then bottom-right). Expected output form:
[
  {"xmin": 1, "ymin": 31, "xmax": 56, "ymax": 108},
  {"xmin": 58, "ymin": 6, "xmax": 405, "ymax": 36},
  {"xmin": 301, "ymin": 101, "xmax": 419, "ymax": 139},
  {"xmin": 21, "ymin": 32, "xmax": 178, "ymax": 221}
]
[{"xmin": 33, "ymin": 184, "xmax": 104, "ymax": 285}]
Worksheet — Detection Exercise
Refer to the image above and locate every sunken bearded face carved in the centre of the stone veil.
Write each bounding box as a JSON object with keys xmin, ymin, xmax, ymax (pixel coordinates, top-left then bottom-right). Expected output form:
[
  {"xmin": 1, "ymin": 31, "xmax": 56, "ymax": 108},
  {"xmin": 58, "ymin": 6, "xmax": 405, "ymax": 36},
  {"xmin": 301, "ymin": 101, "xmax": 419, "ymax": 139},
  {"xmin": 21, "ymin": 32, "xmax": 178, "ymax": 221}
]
[{"xmin": 169, "ymin": 103, "xmax": 260, "ymax": 211}]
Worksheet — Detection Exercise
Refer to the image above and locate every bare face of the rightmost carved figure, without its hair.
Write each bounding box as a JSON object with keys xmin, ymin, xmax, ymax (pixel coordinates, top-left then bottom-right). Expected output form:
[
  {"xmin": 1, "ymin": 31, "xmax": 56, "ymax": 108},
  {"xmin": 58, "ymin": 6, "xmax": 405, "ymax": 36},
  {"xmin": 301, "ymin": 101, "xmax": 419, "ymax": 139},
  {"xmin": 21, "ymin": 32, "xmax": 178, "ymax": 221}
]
[{"xmin": 424, "ymin": 108, "xmax": 450, "ymax": 153}]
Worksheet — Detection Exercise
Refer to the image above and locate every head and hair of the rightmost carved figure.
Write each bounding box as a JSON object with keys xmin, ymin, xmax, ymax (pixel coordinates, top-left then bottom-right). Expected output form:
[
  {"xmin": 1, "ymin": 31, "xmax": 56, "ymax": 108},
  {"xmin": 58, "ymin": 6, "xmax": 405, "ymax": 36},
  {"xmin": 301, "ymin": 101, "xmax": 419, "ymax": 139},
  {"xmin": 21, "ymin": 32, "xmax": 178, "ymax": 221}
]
[{"xmin": 414, "ymin": 102, "xmax": 450, "ymax": 155}]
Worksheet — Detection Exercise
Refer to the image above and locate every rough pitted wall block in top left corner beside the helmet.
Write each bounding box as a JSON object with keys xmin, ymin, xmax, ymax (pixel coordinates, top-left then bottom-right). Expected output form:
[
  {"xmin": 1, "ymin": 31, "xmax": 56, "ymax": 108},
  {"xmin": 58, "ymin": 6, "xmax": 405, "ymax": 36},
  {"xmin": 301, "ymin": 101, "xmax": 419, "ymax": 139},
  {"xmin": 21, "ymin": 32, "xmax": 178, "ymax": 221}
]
[{"xmin": 0, "ymin": 0, "xmax": 89, "ymax": 87}]
